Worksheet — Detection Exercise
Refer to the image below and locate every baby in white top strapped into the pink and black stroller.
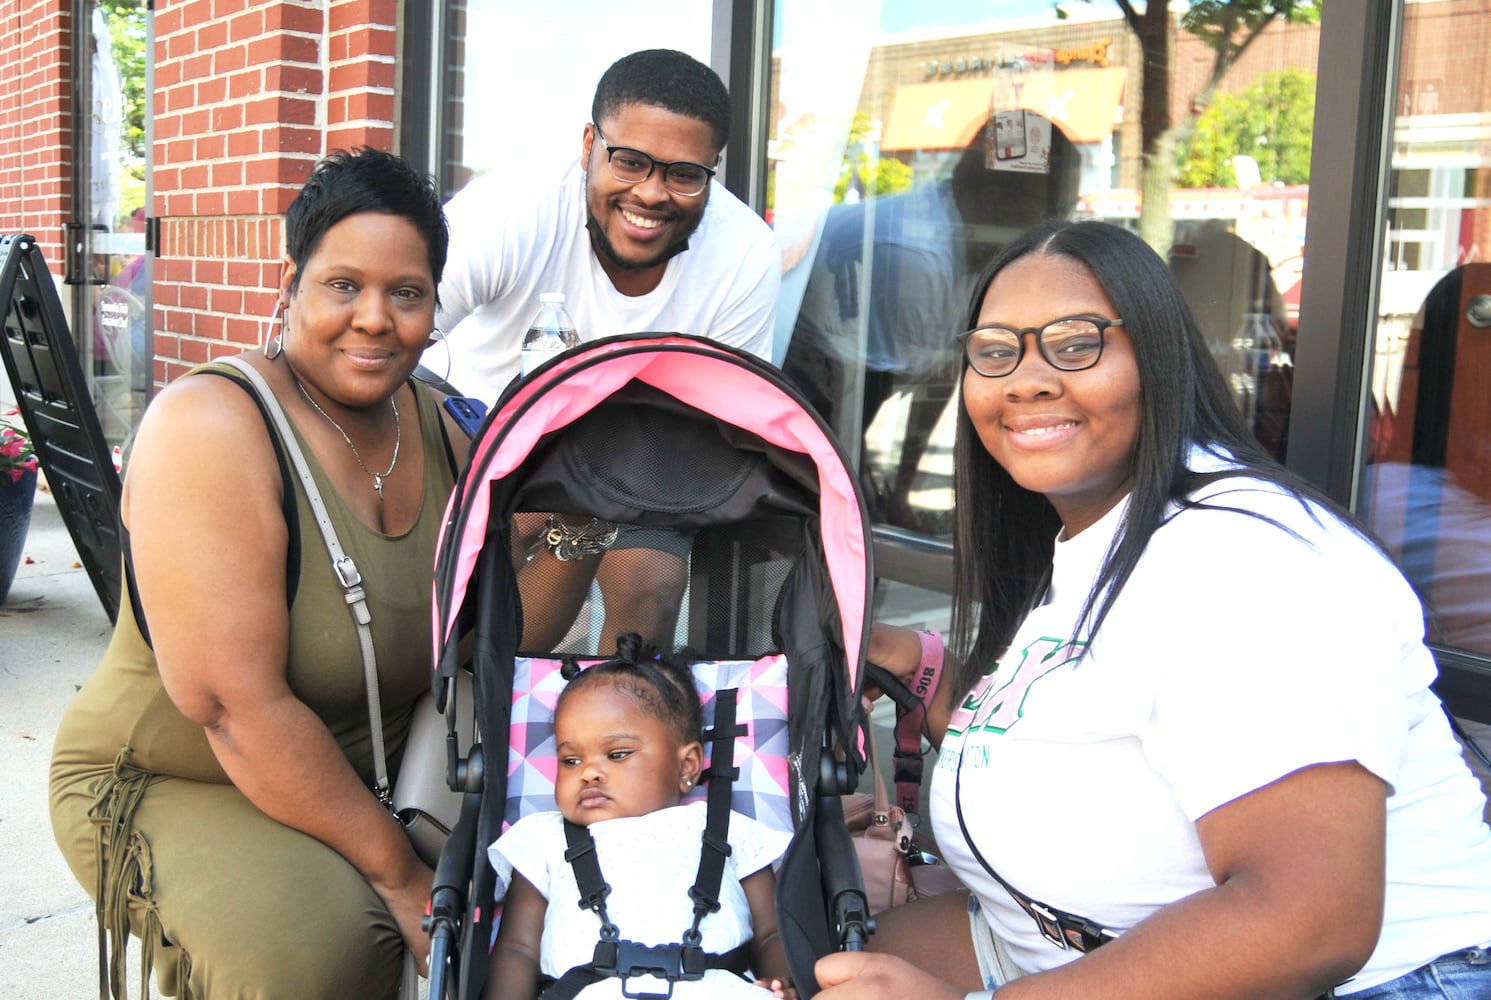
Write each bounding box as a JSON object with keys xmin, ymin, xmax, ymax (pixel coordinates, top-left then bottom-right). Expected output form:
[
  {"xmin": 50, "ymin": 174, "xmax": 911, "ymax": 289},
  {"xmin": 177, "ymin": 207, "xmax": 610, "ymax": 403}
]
[{"xmin": 483, "ymin": 646, "xmax": 796, "ymax": 1000}]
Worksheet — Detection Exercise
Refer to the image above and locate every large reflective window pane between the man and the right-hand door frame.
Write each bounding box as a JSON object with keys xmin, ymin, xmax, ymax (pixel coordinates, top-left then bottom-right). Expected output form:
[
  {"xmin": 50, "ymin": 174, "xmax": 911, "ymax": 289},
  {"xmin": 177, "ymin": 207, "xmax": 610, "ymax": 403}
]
[{"xmin": 768, "ymin": 0, "xmax": 1320, "ymax": 537}]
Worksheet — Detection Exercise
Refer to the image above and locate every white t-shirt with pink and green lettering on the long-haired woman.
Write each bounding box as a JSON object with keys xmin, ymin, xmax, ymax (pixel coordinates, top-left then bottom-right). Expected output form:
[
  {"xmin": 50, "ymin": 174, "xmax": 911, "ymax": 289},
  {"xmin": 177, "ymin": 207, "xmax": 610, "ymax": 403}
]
[{"xmin": 930, "ymin": 456, "xmax": 1491, "ymax": 996}]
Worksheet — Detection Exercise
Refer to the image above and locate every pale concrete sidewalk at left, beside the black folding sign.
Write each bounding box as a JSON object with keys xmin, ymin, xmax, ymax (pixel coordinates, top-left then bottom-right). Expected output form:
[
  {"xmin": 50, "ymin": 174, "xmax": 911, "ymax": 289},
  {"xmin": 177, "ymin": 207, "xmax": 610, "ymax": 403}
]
[{"xmin": 0, "ymin": 479, "xmax": 125, "ymax": 1000}]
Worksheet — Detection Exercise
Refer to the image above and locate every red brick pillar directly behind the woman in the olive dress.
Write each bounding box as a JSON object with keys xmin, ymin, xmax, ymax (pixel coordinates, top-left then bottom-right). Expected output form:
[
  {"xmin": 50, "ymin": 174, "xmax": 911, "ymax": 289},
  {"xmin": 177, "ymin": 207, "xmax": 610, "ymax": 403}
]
[{"xmin": 154, "ymin": 0, "xmax": 398, "ymax": 383}]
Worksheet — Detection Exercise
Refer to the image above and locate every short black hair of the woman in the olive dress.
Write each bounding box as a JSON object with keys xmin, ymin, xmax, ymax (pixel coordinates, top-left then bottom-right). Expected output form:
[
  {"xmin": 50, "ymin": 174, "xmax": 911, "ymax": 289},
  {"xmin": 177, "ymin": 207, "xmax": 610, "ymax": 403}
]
[{"xmin": 285, "ymin": 146, "xmax": 450, "ymax": 303}]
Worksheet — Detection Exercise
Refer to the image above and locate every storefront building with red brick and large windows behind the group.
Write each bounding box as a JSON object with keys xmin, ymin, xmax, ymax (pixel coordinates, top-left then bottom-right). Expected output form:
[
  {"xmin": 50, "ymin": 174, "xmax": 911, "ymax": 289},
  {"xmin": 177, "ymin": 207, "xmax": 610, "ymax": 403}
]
[{"xmin": 0, "ymin": 0, "xmax": 1491, "ymax": 717}]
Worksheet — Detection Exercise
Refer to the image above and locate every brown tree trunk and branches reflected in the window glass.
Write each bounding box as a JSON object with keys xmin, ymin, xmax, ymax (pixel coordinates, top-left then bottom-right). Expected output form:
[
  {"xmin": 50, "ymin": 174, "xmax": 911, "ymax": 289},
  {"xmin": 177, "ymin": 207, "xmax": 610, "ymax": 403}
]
[{"xmin": 1054, "ymin": 0, "xmax": 1321, "ymax": 255}]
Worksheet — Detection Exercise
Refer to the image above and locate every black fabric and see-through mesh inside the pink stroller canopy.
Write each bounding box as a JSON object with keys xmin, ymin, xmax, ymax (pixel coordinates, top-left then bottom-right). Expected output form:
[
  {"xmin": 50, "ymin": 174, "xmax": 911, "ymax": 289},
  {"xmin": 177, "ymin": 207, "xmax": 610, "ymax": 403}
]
[{"xmin": 510, "ymin": 383, "xmax": 814, "ymax": 659}]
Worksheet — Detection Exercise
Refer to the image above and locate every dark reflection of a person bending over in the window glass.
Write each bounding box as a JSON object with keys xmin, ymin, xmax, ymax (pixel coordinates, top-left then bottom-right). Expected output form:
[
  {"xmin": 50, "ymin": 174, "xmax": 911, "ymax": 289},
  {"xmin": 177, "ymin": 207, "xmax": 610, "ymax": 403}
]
[{"xmin": 783, "ymin": 112, "xmax": 1081, "ymax": 535}]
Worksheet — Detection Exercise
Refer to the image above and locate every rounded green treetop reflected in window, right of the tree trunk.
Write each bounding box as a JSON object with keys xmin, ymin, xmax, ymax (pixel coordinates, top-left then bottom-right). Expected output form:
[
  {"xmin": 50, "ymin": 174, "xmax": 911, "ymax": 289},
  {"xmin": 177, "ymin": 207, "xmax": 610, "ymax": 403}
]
[{"xmin": 1176, "ymin": 69, "xmax": 1315, "ymax": 188}]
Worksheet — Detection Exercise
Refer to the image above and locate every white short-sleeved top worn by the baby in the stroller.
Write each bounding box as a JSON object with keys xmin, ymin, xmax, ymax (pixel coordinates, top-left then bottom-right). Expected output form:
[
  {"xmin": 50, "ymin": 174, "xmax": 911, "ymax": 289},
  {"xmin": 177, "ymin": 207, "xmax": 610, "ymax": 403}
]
[{"xmin": 488, "ymin": 802, "xmax": 792, "ymax": 1000}]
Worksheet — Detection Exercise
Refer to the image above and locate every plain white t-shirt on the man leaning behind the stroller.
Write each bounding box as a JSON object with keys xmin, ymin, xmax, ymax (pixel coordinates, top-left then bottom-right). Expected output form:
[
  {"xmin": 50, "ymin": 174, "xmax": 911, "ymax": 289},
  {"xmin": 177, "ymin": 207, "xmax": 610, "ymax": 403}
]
[{"xmin": 426, "ymin": 161, "xmax": 781, "ymax": 405}]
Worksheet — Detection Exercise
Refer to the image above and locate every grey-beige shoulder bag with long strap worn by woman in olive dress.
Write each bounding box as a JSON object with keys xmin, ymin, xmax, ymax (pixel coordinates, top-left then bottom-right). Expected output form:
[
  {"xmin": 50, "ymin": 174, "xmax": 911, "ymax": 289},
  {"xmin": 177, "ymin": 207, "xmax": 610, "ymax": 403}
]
[{"xmin": 224, "ymin": 358, "xmax": 476, "ymax": 867}]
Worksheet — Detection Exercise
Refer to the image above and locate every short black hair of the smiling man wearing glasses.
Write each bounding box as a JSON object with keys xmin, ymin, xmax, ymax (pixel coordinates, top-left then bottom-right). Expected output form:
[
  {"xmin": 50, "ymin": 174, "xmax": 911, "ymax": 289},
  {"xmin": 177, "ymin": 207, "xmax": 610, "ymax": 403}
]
[{"xmin": 590, "ymin": 49, "xmax": 731, "ymax": 152}]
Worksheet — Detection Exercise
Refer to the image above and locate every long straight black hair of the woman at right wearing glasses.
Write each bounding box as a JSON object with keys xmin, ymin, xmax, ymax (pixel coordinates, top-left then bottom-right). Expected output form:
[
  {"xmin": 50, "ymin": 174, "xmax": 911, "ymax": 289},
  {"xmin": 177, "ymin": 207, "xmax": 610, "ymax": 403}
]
[{"xmin": 951, "ymin": 222, "xmax": 1381, "ymax": 692}]
